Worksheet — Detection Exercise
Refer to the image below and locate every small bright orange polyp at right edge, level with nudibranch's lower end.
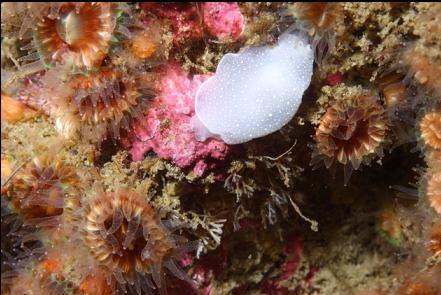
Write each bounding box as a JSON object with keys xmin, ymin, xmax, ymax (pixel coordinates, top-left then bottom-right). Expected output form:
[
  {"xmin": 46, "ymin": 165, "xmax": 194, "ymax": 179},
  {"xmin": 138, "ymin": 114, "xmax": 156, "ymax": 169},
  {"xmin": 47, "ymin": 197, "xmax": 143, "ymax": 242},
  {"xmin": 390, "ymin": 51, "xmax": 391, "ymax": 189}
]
[{"xmin": 420, "ymin": 111, "xmax": 441, "ymax": 149}]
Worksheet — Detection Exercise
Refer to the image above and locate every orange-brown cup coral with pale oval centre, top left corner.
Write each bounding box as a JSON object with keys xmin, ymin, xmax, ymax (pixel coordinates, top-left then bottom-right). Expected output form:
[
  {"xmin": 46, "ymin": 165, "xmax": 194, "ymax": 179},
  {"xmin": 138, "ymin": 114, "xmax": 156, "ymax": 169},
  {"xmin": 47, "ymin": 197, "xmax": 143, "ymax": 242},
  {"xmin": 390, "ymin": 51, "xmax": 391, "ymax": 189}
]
[{"xmin": 10, "ymin": 2, "xmax": 127, "ymax": 74}]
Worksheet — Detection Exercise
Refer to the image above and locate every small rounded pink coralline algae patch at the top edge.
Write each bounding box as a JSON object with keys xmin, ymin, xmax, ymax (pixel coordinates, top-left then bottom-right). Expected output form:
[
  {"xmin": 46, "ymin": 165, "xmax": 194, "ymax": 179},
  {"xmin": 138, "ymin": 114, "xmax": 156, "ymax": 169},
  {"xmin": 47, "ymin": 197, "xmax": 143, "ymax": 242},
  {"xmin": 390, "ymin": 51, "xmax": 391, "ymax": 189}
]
[{"xmin": 202, "ymin": 2, "xmax": 244, "ymax": 40}]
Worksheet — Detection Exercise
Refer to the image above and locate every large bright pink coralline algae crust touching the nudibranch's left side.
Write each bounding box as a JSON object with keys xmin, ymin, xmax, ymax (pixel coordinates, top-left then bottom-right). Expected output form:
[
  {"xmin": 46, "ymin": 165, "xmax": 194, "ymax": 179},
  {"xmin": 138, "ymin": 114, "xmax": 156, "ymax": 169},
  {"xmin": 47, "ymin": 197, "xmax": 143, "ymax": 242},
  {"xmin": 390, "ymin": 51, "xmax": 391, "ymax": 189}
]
[{"xmin": 122, "ymin": 63, "xmax": 230, "ymax": 175}]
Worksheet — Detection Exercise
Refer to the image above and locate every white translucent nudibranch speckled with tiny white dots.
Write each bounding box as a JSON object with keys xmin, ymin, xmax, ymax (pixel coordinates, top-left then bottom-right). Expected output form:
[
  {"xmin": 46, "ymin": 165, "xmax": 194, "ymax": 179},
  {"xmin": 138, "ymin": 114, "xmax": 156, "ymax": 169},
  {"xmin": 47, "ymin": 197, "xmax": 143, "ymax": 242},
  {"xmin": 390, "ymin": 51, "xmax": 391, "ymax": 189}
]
[{"xmin": 192, "ymin": 32, "xmax": 314, "ymax": 144}]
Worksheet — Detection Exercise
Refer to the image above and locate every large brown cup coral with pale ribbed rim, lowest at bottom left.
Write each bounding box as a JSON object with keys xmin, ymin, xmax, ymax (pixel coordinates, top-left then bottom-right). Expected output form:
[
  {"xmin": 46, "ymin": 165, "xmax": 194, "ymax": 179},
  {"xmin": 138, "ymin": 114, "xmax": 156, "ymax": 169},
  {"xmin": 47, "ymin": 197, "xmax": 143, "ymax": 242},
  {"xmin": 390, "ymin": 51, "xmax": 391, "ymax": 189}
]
[{"xmin": 84, "ymin": 189, "xmax": 192, "ymax": 293}]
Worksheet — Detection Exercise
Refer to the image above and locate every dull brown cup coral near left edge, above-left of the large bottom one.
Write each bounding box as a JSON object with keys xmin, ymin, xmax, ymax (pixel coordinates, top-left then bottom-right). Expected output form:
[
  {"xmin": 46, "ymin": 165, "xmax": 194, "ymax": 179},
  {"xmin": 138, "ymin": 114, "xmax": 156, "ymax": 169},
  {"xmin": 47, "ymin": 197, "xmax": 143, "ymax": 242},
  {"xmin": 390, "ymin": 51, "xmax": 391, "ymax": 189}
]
[{"xmin": 7, "ymin": 156, "xmax": 79, "ymax": 220}]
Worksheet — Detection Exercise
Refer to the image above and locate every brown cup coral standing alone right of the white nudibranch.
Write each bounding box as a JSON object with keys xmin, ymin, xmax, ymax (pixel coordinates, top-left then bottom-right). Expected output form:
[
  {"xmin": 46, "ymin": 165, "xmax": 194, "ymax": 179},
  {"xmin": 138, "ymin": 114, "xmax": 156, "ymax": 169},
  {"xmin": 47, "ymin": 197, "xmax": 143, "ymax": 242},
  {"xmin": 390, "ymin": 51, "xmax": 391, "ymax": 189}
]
[{"xmin": 314, "ymin": 94, "xmax": 388, "ymax": 180}]
